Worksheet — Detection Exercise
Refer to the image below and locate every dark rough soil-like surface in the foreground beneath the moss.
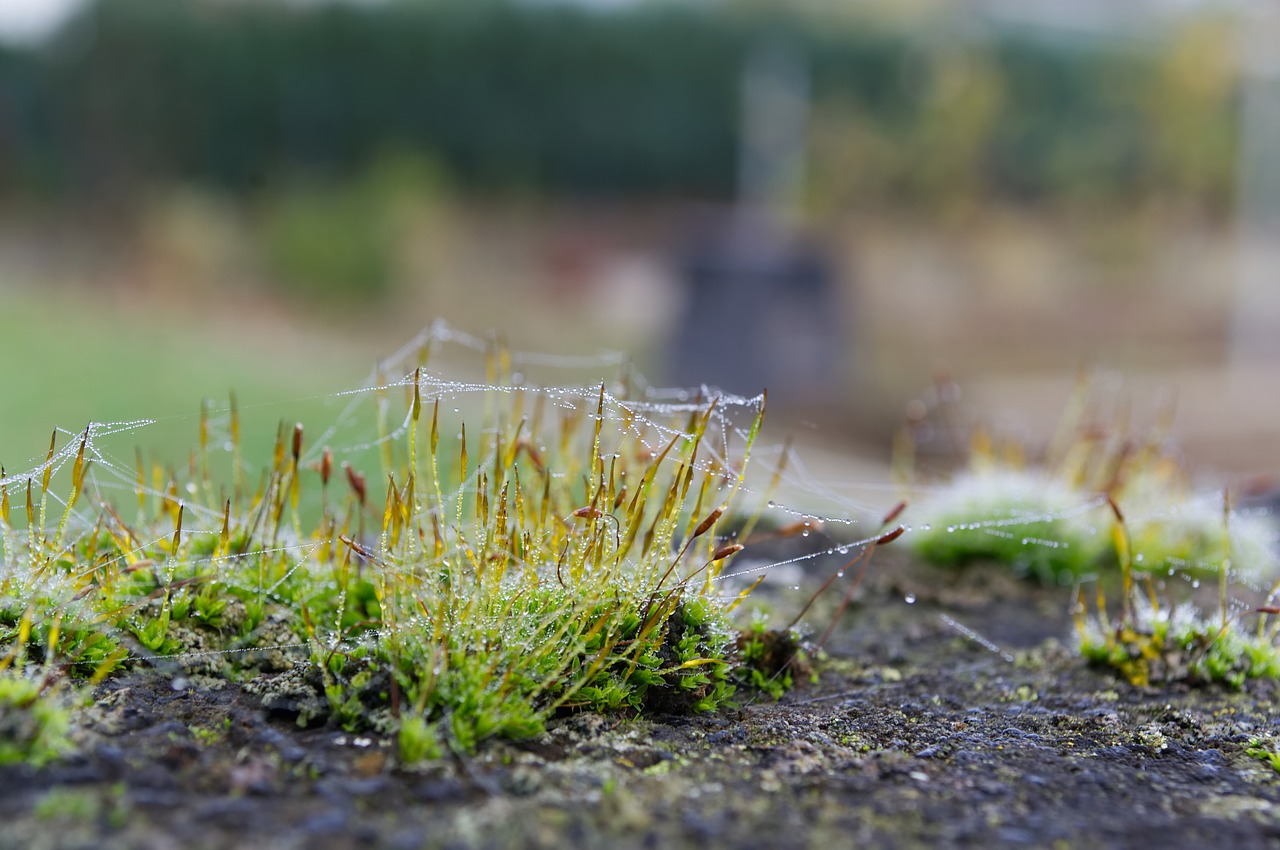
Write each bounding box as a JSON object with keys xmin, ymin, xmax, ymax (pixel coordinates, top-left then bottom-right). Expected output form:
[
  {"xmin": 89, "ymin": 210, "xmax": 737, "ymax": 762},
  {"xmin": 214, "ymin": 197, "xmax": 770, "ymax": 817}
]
[{"xmin": 0, "ymin": 561, "xmax": 1280, "ymax": 850}]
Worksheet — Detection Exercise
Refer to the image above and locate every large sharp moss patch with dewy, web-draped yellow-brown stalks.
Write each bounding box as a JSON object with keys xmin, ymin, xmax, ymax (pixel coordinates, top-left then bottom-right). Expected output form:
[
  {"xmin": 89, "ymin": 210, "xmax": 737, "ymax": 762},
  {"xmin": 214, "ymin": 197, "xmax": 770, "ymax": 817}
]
[{"xmin": 0, "ymin": 337, "xmax": 808, "ymax": 760}]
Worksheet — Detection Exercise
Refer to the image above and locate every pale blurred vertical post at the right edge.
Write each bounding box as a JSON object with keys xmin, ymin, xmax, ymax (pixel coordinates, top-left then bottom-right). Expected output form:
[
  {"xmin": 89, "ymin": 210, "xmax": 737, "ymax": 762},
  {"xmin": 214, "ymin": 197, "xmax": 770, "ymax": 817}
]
[{"xmin": 1231, "ymin": 4, "xmax": 1280, "ymax": 367}]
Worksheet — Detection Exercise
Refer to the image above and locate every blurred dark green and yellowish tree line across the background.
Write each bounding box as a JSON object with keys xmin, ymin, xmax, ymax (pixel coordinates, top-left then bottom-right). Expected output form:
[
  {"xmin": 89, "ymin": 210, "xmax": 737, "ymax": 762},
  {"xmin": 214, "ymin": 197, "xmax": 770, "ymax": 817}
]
[{"xmin": 0, "ymin": 0, "xmax": 1238, "ymax": 211}]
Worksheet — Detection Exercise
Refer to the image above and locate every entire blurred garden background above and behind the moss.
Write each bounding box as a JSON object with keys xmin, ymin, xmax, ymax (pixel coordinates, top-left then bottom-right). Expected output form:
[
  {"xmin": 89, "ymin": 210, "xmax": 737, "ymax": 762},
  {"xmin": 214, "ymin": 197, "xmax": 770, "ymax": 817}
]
[{"xmin": 0, "ymin": 0, "xmax": 1280, "ymax": 475}]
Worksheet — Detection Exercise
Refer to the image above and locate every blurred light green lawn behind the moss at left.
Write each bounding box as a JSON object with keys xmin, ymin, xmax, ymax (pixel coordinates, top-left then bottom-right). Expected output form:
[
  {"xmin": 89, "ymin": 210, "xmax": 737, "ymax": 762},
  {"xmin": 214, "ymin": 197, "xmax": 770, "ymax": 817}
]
[{"xmin": 0, "ymin": 289, "xmax": 384, "ymax": 474}]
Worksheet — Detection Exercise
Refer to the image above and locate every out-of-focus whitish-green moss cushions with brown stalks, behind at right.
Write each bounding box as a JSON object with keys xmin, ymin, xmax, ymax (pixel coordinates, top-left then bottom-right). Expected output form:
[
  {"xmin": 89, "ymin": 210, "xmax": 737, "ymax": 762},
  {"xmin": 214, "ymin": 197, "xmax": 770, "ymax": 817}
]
[{"xmin": 910, "ymin": 381, "xmax": 1280, "ymax": 584}]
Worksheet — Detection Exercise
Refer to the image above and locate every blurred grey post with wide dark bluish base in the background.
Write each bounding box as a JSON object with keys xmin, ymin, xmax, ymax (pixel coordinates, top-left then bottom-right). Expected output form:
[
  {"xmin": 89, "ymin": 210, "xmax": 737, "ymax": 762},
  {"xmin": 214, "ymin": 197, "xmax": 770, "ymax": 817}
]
[{"xmin": 669, "ymin": 41, "xmax": 841, "ymax": 407}]
